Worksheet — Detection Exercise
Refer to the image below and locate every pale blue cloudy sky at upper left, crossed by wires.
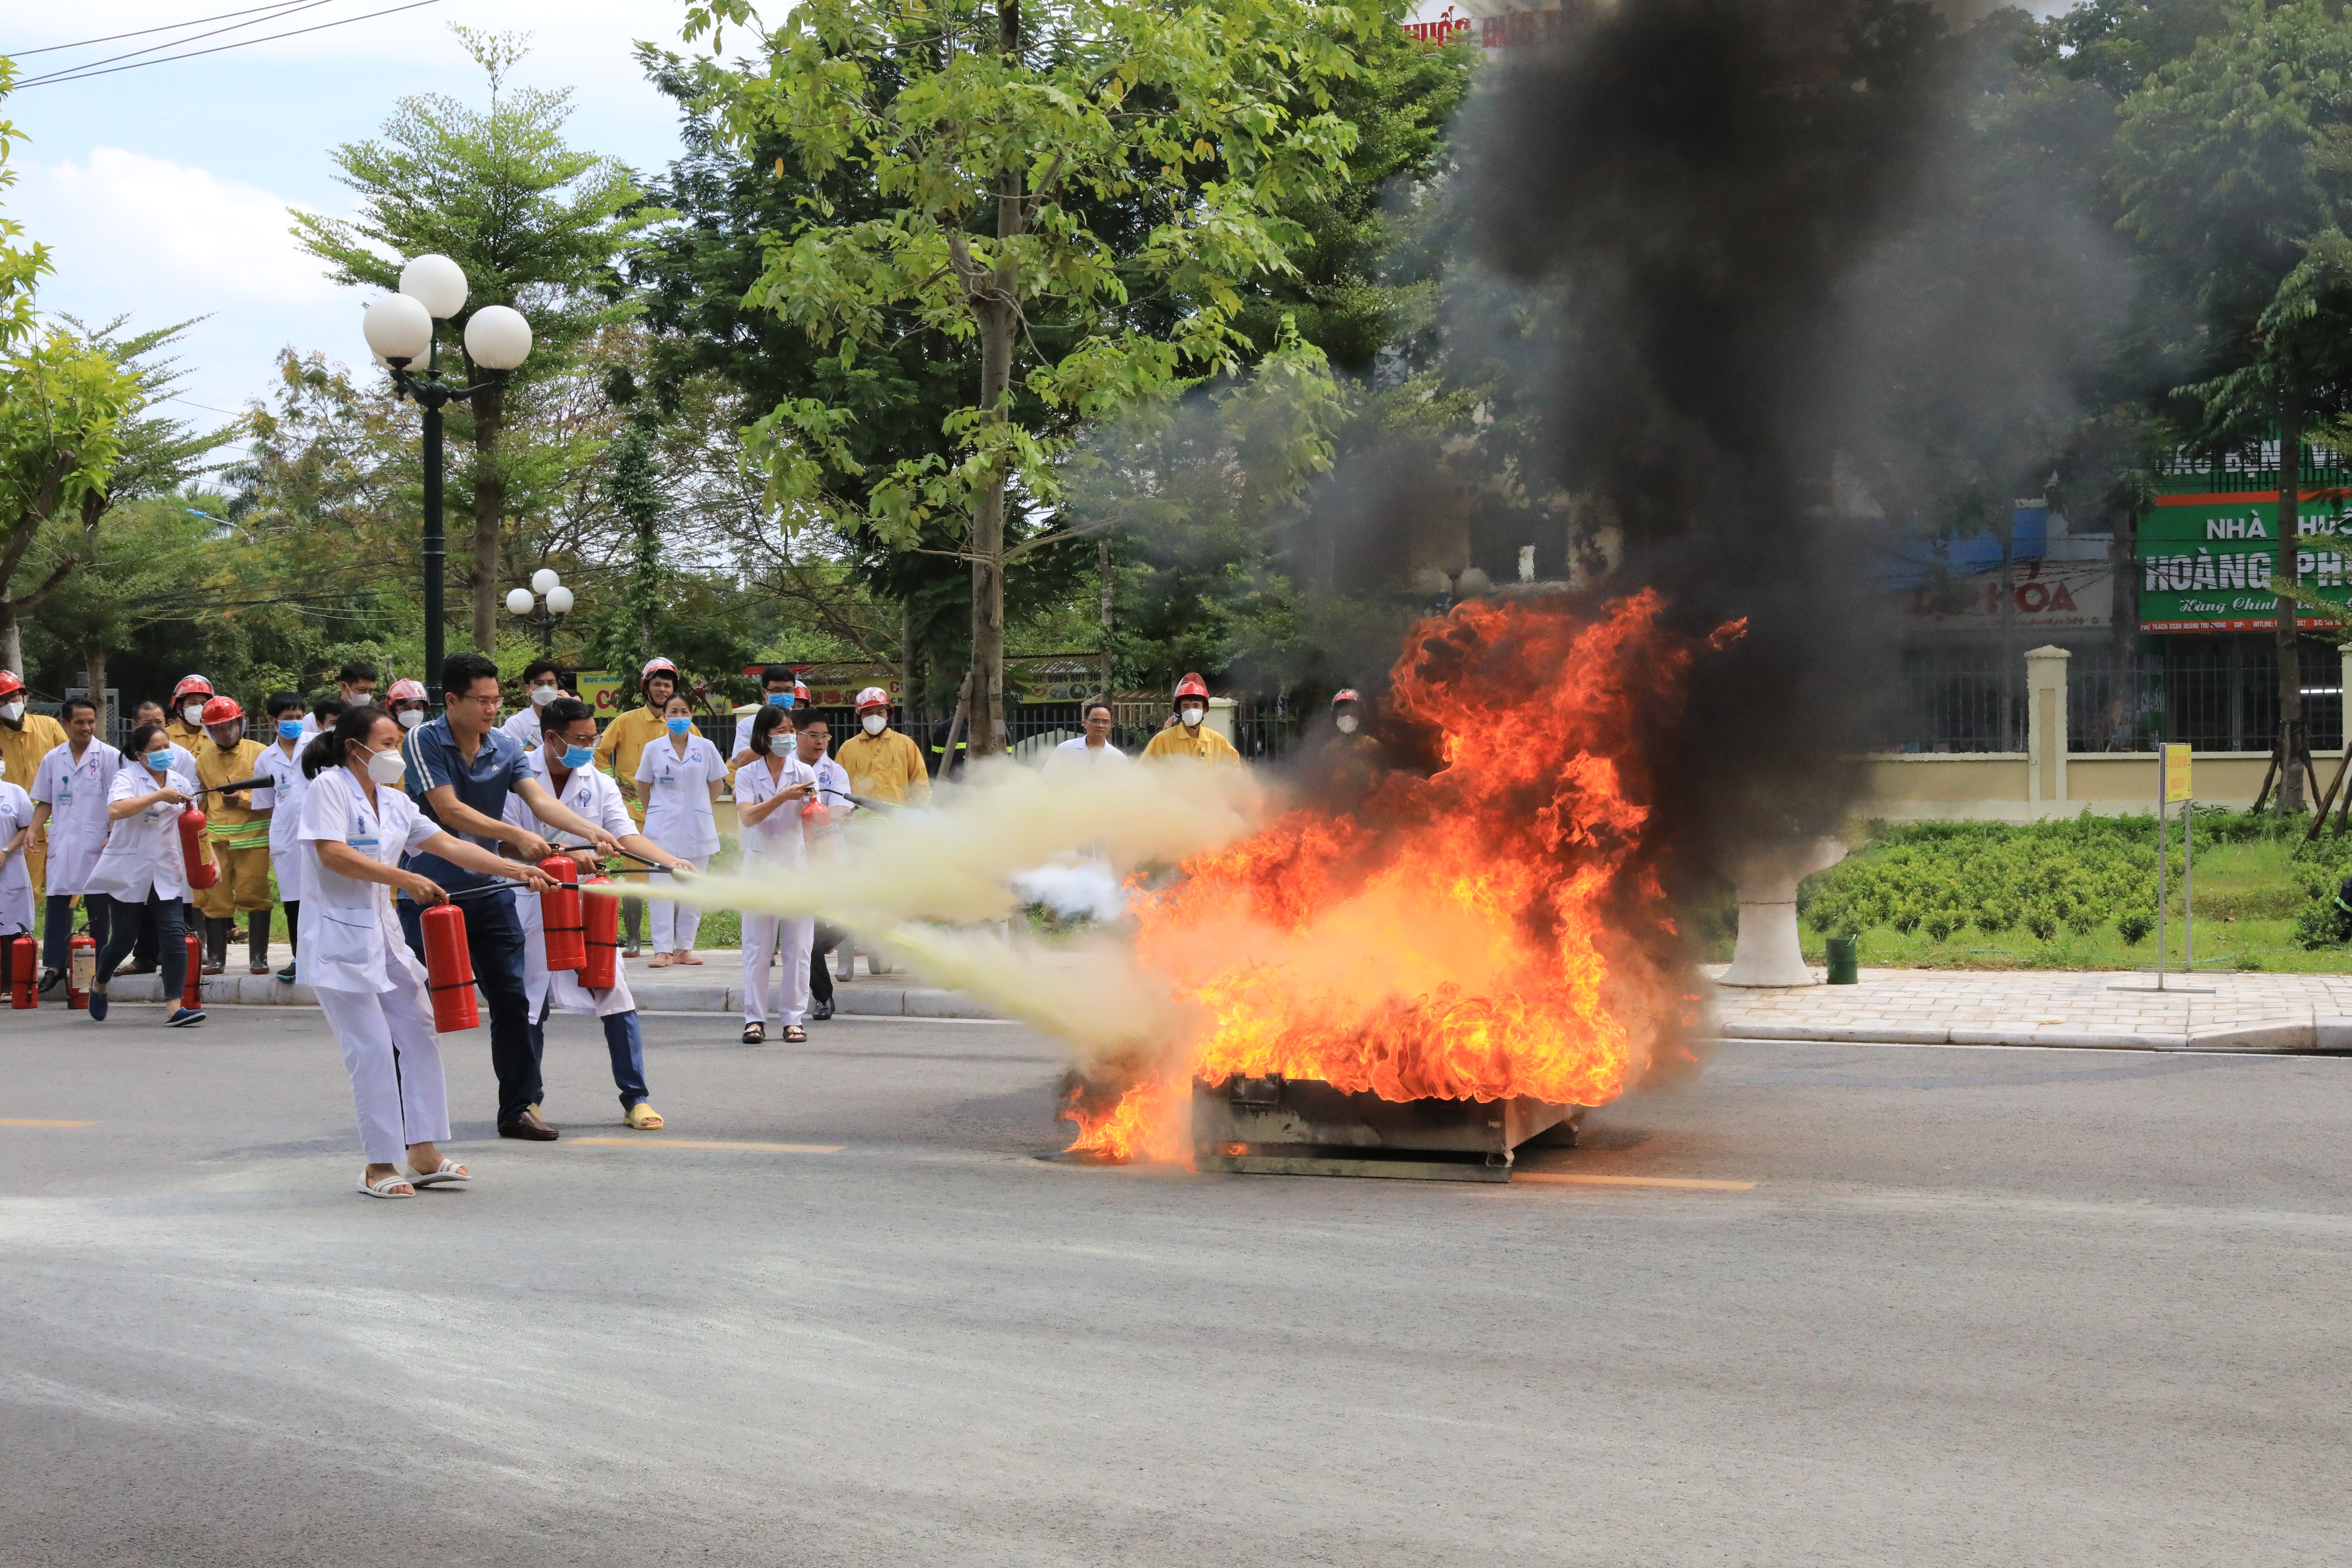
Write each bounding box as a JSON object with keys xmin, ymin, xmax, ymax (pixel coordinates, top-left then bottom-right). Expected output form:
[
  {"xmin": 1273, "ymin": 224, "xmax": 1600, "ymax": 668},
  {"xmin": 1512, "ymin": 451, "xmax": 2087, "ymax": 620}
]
[{"xmin": 0, "ymin": 0, "xmax": 685, "ymax": 426}]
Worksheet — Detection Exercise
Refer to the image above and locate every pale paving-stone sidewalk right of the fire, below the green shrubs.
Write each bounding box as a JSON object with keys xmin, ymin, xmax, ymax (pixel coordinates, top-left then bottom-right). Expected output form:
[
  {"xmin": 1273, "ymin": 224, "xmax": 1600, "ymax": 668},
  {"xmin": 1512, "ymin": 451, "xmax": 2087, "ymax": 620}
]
[{"xmin": 1708, "ymin": 966, "xmax": 2352, "ymax": 1051}]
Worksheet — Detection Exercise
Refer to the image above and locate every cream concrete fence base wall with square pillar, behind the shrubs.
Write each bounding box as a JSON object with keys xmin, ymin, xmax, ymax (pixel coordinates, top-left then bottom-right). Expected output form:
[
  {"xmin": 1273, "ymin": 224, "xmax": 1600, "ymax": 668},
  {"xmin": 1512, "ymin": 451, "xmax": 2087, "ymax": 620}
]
[{"xmin": 1863, "ymin": 649, "xmax": 2352, "ymax": 823}]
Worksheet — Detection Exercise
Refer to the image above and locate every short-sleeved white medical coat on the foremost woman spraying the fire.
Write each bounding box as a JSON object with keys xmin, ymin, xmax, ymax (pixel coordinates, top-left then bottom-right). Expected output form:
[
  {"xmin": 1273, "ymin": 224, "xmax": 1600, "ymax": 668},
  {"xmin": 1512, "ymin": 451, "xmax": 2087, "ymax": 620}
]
[{"xmin": 301, "ymin": 769, "xmax": 440, "ymax": 992}]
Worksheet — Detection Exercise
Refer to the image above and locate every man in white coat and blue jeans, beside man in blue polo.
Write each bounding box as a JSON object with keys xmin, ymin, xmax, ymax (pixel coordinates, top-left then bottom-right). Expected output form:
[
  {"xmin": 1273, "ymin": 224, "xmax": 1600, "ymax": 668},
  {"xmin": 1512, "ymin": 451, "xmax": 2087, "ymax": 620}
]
[{"xmin": 491, "ymin": 696, "xmax": 692, "ymax": 1131}]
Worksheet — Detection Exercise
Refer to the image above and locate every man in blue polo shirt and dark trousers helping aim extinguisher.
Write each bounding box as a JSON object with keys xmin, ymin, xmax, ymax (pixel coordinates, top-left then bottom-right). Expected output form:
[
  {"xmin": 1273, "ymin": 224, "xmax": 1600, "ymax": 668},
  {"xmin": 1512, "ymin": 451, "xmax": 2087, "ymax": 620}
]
[{"xmin": 400, "ymin": 653, "xmax": 621, "ymax": 1142}]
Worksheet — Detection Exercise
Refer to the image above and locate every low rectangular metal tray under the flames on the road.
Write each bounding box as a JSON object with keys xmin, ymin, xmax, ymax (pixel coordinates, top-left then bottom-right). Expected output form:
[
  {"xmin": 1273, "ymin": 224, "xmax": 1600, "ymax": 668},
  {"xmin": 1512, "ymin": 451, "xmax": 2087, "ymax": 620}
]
[{"xmin": 1192, "ymin": 1074, "xmax": 1585, "ymax": 1182}]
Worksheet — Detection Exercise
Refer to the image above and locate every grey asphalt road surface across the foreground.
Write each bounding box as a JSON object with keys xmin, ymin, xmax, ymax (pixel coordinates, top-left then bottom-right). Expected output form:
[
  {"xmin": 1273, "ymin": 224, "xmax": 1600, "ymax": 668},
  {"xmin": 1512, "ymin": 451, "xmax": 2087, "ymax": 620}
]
[{"xmin": 0, "ymin": 1008, "xmax": 2352, "ymax": 1568}]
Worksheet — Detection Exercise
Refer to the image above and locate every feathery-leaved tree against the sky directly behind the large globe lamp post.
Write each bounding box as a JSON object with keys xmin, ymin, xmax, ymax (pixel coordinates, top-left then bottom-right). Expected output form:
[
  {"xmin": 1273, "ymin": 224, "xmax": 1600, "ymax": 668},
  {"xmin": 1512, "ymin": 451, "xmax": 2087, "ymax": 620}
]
[{"xmin": 294, "ymin": 28, "xmax": 663, "ymax": 651}]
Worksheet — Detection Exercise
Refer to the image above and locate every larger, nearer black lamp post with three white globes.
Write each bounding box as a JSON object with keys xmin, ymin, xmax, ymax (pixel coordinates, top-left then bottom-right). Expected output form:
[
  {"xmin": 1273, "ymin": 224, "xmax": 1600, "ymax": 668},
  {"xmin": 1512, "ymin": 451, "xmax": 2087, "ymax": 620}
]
[{"xmin": 360, "ymin": 256, "xmax": 532, "ymax": 708}]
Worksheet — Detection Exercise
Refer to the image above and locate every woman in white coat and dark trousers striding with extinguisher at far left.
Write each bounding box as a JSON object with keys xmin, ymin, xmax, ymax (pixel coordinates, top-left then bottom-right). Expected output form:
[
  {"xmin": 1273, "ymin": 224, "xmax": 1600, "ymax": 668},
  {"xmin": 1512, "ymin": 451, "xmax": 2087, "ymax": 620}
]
[{"xmin": 85, "ymin": 724, "xmax": 205, "ymax": 1030}]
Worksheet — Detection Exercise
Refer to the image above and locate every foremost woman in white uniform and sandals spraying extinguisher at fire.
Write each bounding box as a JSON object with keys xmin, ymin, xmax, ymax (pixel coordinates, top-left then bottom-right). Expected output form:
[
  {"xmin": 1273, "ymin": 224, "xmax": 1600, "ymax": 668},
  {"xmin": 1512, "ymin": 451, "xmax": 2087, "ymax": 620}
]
[{"xmin": 301, "ymin": 705, "xmax": 550, "ymax": 1199}]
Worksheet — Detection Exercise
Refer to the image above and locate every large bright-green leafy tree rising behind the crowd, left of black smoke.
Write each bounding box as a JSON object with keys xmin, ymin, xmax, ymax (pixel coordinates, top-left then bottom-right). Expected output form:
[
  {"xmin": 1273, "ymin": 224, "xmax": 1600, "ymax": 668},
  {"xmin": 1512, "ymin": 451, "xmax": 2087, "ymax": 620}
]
[{"xmin": 687, "ymin": 0, "xmax": 1388, "ymax": 743}]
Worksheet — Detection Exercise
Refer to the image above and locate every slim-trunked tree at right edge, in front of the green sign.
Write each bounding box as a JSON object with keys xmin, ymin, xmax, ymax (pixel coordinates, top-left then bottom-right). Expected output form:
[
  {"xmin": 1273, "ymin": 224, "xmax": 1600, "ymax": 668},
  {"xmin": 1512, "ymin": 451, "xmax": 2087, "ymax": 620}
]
[{"xmin": 2112, "ymin": 0, "xmax": 2352, "ymax": 811}]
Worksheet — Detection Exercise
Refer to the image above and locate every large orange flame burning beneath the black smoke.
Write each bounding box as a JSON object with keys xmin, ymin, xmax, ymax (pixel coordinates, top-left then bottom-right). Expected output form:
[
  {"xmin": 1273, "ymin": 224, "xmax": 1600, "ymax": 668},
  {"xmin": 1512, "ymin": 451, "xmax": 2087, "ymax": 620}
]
[{"xmin": 1063, "ymin": 590, "xmax": 1743, "ymax": 1159}]
